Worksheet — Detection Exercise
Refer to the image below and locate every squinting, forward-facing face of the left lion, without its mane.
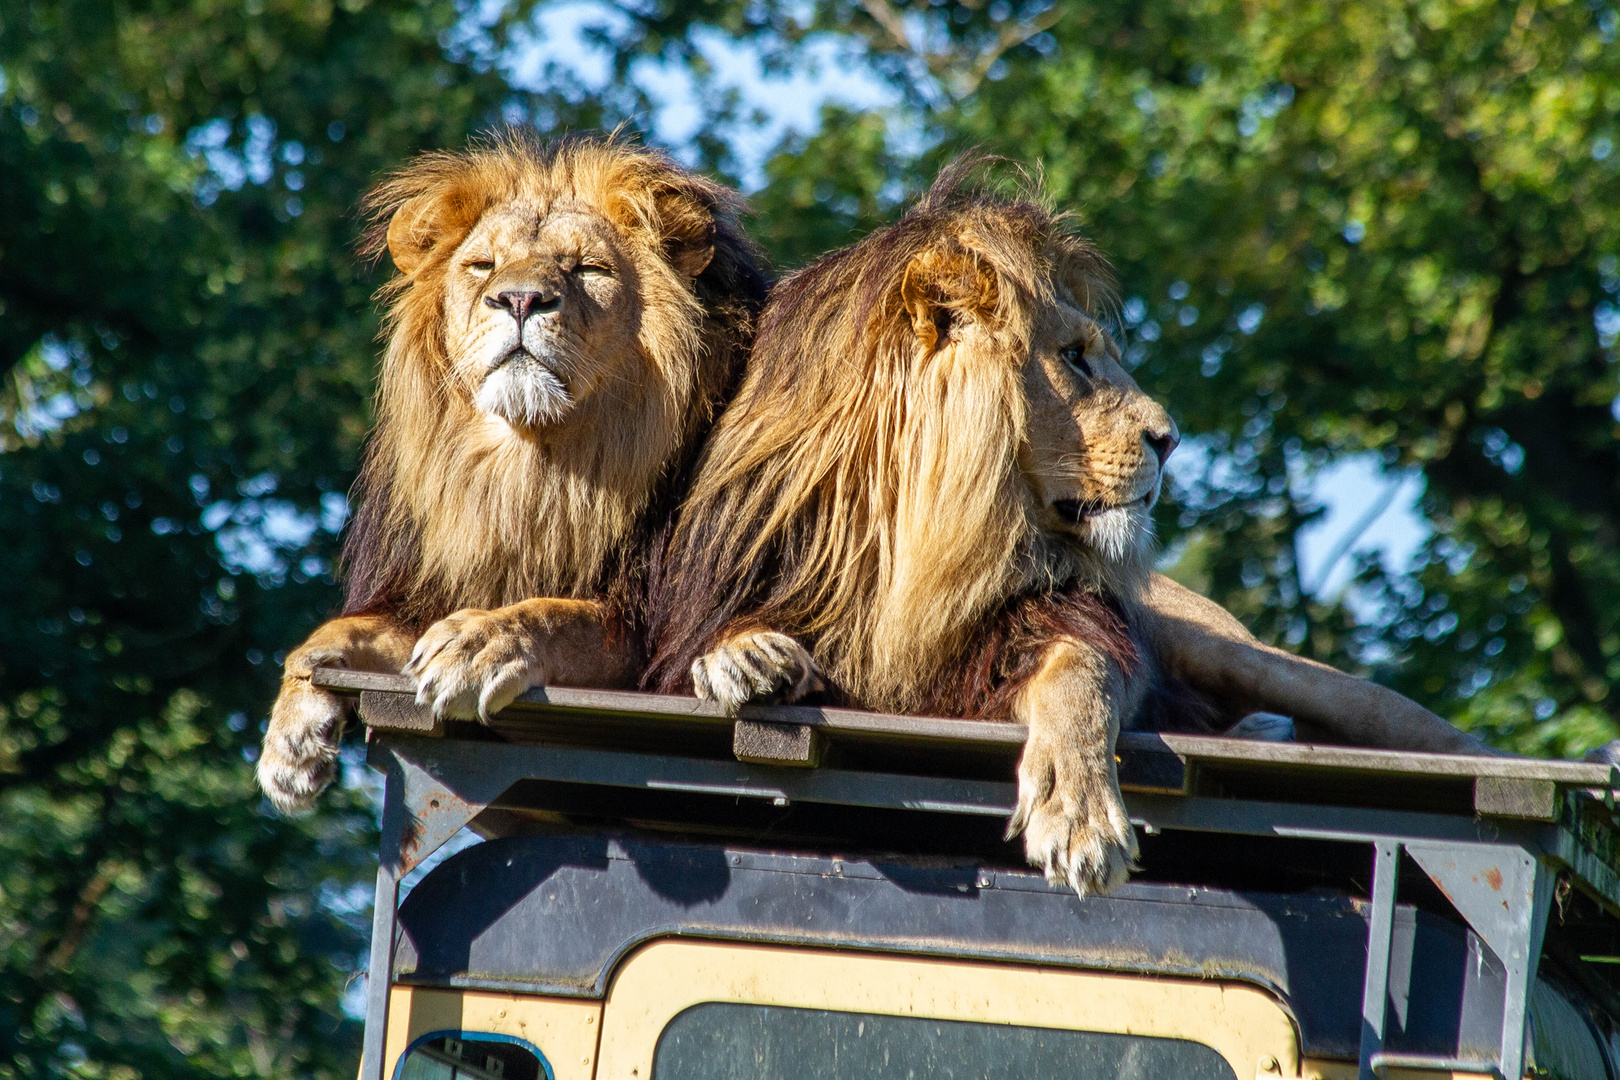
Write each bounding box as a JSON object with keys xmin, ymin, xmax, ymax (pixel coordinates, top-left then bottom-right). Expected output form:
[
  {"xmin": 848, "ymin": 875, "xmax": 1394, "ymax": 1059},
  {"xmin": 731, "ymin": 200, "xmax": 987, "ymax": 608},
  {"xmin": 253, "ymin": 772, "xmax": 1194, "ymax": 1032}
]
[{"xmin": 444, "ymin": 202, "xmax": 637, "ymax": 429}]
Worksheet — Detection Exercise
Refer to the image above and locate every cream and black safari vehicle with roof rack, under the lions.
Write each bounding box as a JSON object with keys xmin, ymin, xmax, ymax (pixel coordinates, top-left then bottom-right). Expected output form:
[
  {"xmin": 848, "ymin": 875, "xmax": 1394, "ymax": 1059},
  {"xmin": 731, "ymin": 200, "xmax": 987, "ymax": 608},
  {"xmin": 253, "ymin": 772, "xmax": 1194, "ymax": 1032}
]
[{"xmin": 325, "ymin": 670, "xmax": 1620, "ymax": 1080}]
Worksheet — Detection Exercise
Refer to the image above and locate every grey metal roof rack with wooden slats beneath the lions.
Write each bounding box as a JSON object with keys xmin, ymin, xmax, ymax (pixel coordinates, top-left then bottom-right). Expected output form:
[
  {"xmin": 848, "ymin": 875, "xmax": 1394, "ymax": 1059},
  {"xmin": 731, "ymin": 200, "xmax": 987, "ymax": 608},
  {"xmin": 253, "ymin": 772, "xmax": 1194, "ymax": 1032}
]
[{"xmin": 314, "ymin": 669, "xmax": 1620, "ymax": 1080}]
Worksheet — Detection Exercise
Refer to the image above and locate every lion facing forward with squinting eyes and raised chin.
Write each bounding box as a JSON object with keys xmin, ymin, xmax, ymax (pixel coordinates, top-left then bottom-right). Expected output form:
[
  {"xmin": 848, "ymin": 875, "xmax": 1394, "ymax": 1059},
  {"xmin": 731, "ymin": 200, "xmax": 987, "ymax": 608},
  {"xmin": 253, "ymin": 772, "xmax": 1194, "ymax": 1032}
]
[{"xmin": 258, "ymin": 131, "xmax": 770, "ymax": 811}]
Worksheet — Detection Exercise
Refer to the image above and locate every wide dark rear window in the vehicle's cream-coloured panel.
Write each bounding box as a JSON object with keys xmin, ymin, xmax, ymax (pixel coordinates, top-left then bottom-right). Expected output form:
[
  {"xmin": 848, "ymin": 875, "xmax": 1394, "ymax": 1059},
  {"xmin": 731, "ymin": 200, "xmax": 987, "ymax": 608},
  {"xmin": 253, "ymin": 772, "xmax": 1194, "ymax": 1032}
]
[{"xmin": 653, "ymin": 1002, "xmax": 1236, "ymax": 1080}]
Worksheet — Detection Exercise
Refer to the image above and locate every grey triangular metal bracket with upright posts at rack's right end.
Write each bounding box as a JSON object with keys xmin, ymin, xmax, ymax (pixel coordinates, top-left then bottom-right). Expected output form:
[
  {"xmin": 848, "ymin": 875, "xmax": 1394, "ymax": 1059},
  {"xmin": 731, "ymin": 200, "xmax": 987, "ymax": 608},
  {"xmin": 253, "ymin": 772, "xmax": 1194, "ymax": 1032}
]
[{"xmin": 1359, "ymin": 840, "xmax": 1554, "ymax": 1080}]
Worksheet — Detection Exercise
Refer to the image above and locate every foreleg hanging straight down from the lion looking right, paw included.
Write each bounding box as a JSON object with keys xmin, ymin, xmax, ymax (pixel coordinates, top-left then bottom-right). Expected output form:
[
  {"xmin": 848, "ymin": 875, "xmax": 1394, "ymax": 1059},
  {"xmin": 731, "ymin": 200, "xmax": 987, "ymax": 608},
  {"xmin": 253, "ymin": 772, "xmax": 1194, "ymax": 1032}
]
[{"xmin": 1008, "ymin": 641, "xmax": 1137, "ymax": 895}]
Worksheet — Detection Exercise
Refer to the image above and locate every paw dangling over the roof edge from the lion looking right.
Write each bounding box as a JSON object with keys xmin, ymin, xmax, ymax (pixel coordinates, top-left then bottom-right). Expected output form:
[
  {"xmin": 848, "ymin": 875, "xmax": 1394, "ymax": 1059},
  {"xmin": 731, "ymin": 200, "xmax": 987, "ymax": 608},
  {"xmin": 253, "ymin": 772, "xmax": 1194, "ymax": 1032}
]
[{"xmin": 1008, "ymin": 737, "xmax": 1137, "ymax": 897}]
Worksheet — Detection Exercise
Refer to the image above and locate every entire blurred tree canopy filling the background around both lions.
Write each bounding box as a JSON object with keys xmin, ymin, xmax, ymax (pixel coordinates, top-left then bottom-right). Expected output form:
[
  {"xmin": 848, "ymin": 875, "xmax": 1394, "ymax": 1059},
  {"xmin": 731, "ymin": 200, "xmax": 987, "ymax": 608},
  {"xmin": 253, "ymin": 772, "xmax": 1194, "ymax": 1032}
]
[{"xmin": 0, "ymin": 0, "xmax": 1620, "ymax": 1077}]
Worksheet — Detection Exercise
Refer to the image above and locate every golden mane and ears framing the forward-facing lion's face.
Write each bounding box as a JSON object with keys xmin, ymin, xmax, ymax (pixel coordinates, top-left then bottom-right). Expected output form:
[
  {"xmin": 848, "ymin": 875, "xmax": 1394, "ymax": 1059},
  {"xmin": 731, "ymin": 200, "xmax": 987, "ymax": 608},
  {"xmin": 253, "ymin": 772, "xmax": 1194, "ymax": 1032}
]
[{"xmin": 343, "ymin": 130, "xmax": 766, "ymax": 627}]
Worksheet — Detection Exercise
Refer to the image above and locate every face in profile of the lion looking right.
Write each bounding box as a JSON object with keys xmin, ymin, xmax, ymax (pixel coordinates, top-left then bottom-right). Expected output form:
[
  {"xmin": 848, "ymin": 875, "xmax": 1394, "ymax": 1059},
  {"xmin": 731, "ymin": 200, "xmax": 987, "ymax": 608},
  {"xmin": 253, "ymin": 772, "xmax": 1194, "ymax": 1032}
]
[{"xmin": 1019, "ymin": 300, "xmax": 1179, "ymax": 562}]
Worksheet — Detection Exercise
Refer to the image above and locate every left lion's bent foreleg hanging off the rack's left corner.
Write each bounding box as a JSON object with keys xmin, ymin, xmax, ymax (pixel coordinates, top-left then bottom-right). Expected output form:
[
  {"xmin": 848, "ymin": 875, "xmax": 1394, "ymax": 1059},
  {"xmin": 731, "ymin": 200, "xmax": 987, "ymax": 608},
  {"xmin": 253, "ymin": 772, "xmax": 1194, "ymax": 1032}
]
[{"xmin": 258, "ymin": 615, "xmax": 416, "ymax": 813}]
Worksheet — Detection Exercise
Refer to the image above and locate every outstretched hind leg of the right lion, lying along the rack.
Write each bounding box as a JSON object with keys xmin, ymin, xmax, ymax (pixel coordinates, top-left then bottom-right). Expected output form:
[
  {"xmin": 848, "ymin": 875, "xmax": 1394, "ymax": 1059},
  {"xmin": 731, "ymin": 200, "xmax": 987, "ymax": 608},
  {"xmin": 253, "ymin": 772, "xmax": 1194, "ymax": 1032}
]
[{"xmin": 1144, "ymin": 575, "xmax": 1495, "ymax": 755}]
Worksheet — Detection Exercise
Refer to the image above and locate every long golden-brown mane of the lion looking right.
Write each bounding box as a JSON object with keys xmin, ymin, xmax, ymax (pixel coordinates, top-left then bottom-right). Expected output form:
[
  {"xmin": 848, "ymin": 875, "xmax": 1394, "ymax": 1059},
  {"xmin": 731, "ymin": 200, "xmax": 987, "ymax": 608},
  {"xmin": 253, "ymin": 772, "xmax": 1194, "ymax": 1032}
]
[{"xmin": 643, "ymin": 162, "xmax": 1144, "ymax": 714}]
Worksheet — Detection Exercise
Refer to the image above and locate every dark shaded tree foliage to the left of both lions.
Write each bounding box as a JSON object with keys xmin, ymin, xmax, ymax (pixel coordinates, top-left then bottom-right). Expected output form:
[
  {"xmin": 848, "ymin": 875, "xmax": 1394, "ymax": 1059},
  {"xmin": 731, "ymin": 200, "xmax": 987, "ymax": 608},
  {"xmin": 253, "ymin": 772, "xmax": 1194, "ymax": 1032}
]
[{"xmin": 0, "ymin": 0, "xmax": 565, "ymax": 1077}]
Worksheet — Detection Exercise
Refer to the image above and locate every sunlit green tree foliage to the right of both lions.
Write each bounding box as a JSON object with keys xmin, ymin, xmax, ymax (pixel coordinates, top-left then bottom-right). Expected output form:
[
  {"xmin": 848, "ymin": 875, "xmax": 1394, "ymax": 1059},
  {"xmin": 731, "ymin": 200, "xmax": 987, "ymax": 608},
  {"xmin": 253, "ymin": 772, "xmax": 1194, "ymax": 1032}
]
[{"xmin": 738, "ymin": 0, "xmax": 1620, "ymax": 755}]
